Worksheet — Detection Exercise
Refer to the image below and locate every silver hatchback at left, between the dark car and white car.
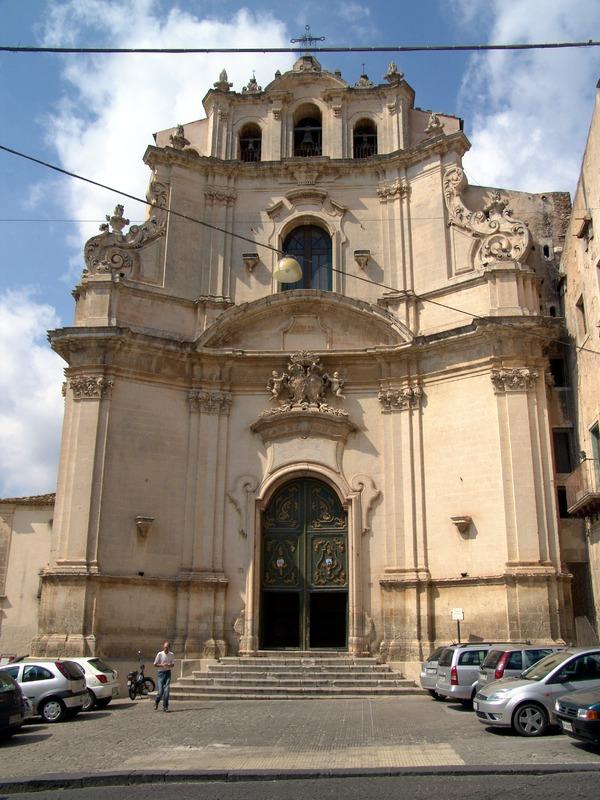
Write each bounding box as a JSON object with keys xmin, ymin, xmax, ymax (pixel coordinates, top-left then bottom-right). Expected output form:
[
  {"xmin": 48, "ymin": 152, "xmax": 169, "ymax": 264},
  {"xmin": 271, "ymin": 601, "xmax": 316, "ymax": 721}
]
[{"xmin": 0, "ymin": 658, "xmax": 86, "ymax": 722}]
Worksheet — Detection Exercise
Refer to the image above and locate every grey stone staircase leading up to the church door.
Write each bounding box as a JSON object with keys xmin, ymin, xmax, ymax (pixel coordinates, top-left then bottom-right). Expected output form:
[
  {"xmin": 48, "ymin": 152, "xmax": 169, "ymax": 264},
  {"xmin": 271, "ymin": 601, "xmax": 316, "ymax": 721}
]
[{"xmin": 171, "ymin": 651, "xmax": 426, "ymax": 700}]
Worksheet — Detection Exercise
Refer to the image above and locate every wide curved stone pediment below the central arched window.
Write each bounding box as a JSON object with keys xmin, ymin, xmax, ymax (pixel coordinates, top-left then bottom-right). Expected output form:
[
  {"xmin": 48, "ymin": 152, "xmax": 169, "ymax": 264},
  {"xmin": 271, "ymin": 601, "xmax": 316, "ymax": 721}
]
[{"xmin": 196, "ymin": 289, "xmax": 412, "ymax": 351}]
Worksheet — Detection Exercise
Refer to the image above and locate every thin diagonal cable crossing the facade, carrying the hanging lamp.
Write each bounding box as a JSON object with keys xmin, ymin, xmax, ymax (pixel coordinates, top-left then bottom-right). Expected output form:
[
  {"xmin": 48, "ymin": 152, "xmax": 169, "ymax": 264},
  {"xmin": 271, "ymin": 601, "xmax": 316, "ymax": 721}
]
[{"xmin": 0, "ymin": 144, "xmax": 600, "ymax": 356}]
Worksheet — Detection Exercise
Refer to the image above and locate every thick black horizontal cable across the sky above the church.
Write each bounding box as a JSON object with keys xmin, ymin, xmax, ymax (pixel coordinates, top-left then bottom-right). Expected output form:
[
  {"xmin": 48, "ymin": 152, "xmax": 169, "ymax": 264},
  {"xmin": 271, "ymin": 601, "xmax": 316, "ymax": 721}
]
[{"xmin": 0, "ymin": 39, "xmax": 600, "ymax": 55}]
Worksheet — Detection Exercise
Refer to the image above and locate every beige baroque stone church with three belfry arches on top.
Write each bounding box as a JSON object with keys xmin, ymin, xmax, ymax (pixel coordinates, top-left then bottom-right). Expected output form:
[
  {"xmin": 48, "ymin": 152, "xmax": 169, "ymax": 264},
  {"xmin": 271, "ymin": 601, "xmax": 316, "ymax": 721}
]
[{"xmin": 14, "ymin": 54, "xmax": 584, "ymax": 665}]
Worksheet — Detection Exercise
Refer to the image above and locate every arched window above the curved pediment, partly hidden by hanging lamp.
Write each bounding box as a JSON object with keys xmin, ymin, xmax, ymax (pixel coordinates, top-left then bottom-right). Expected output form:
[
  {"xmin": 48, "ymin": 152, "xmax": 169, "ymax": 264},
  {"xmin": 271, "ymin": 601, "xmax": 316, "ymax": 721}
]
[{"xmin": 283, "ymin": 225, "xmax": 333, "ymax": 291}]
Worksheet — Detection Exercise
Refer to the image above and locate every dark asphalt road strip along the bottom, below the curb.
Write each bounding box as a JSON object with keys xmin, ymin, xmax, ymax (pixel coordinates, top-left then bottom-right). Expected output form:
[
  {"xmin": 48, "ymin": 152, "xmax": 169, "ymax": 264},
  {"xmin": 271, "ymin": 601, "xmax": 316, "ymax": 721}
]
[{"xmin": 2, "ymin": 773, "xmax": 599, "ymax": 800}]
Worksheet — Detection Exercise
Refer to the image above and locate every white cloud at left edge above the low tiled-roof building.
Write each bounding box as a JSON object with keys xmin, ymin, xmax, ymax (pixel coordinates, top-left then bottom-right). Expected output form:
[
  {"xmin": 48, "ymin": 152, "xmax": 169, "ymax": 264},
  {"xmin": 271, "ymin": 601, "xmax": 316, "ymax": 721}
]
[{"xmin": 0, "ymin": 289, "xmax": 64, "ymax": 497}]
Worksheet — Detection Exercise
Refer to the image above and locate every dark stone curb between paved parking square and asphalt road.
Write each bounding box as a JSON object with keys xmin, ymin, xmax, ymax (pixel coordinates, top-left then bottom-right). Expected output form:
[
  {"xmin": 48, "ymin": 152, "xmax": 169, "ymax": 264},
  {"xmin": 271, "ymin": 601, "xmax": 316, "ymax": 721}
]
[{"xmin": 0, "ymin": 763, "xmax": 600, "ymax": 794}]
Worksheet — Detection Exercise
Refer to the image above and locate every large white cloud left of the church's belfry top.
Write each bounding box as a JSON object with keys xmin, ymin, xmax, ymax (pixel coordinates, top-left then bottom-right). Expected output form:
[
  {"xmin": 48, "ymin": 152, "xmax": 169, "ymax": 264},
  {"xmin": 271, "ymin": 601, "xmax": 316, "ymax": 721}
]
[{"xmin": 43, "ymin": 0, "xmax": 293, "ymax": 279}]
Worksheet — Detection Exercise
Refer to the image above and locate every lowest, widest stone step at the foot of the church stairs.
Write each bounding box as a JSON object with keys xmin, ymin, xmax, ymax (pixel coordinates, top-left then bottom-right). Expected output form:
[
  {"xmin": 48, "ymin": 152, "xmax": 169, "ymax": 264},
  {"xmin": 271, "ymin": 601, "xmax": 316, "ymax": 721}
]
[{"xmin": 170, "ymin": 684, "xmax": 427, "ymax": 700}]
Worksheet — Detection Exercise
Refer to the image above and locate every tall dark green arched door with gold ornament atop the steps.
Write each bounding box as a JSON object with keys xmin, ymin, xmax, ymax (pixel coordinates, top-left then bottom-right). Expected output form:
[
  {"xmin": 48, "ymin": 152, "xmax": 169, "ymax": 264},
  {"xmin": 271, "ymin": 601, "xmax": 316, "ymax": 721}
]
[{"xmin": 260, "ymin": 478, "xmax": 348, "ymax": 650}]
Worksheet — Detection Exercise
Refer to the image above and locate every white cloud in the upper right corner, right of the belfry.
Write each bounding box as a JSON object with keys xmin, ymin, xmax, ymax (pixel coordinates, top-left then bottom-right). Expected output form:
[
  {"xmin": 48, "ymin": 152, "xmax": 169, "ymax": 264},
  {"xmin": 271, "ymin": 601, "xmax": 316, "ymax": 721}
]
[{"xmin": 454, "ymin": 0, "xmax": 600, "ymax": 192}]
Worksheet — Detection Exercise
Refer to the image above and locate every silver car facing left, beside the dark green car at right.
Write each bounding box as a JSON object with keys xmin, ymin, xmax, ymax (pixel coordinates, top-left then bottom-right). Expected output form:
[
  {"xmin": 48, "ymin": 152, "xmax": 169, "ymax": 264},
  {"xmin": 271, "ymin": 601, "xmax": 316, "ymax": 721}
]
[{"xmin": 473, "ymin": 647, "xmax": 600, "ymax": 736}]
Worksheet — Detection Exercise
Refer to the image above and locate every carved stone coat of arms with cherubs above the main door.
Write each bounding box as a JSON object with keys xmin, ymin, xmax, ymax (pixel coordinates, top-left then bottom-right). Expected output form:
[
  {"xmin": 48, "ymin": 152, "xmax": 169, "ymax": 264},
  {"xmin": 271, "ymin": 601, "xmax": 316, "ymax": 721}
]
[{"xmin": 262, "ymin": 350, "xmax": 348, "ymax": 417}]
